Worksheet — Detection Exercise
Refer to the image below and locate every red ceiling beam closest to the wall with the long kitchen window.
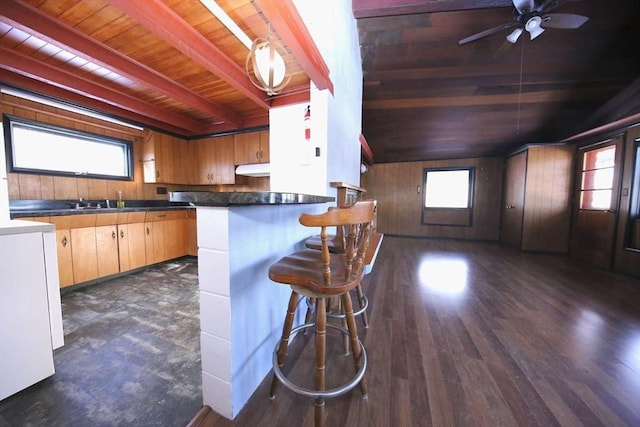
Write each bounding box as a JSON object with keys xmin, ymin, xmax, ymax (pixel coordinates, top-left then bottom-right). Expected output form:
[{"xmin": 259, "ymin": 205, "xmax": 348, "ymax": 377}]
[{"xmin": 0, "ymin": 68, "xmax": 192, "ymax": 135}]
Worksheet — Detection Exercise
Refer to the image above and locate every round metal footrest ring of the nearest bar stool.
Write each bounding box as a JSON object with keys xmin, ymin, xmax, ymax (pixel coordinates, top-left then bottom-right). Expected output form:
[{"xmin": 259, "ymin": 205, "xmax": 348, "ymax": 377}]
[{"xmin": 273, "ymin": 324, "xmax": 367, "ymax": 399}]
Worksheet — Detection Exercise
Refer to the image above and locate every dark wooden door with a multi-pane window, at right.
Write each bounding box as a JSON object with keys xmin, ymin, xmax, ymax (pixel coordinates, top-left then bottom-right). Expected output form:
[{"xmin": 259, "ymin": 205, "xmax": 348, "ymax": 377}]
[{"xmin": 570, "ymin": 136, "xmax": 622, "ymax": 269}]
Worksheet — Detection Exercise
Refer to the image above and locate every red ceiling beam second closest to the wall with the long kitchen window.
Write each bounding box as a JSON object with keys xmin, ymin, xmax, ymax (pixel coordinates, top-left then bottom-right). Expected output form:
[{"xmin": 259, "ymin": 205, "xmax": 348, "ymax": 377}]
[{"xmin": 0, "ymin": 47, "xmax": 202, "ymax": 131}]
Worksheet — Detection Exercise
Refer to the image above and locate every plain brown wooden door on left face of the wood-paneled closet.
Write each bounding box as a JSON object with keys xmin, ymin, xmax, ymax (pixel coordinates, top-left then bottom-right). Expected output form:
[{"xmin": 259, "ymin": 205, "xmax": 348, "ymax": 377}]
[{"xmin": 500, "ymin": 151, "xmax": 527, "ymax": 248}]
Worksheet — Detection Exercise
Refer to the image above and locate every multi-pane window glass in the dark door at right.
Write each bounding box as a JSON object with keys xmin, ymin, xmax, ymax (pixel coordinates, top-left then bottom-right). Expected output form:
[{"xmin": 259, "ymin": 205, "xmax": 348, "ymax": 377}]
[{"xmin": 580, "ymin": 145, "xmax": 616, "ymax": 210}]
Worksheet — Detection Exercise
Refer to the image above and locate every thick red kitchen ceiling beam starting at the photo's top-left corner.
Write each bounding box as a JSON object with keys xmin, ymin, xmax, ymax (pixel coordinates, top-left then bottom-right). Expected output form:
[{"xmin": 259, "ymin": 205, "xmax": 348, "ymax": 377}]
[{"xmin": 0, "ymin": 0, "xmax": 242, "ymax": 125}]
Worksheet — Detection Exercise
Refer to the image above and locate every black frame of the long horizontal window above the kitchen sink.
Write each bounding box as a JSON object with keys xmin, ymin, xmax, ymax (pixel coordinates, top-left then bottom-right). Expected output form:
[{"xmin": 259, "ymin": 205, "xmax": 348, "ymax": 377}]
[{"xmin": 2, "ymin": 114, "xmax": 134, "ymax": 181}]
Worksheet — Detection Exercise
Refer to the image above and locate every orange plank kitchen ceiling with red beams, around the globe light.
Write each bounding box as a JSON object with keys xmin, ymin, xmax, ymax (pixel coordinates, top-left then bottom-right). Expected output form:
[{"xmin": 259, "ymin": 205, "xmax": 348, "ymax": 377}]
[{"xmin": 0, "ymin": 0, "xmax": 332, "ymax": 137}]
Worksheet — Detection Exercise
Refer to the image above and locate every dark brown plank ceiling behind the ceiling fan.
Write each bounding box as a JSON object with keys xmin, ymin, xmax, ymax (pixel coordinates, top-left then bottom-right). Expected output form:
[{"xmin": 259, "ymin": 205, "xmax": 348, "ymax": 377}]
[{"xmin": 353, "ymin": 0, "xmax": 640, "ymax": 163}]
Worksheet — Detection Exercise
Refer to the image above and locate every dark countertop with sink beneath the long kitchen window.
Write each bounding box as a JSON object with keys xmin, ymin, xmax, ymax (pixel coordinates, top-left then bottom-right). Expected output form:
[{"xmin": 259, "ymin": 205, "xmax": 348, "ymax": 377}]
[{"xmin": 9, "ymin": 200, "xmax": 193, "ymax": 219}]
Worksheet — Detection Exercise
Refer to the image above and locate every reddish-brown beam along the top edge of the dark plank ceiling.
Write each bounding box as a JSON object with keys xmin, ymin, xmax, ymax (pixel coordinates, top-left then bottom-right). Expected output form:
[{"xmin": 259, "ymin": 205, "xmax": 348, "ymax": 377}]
[{"xmin": 351, "ymin": 0, "xmax": 513, "ymax": 19}]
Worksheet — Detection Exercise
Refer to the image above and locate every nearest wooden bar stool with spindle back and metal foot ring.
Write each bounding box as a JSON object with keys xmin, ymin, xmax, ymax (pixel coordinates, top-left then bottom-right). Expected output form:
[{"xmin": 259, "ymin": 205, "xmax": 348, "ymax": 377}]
[{"xmin": 269, "ymin": 200, "xmax": 376, "ymax": 426}]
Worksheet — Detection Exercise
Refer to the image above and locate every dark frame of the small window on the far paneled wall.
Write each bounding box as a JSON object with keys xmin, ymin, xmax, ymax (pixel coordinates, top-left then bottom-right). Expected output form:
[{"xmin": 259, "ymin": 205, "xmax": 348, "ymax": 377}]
[{"xmin": 420, "ymin": 166, "xmax": 476, "ymax": 227}]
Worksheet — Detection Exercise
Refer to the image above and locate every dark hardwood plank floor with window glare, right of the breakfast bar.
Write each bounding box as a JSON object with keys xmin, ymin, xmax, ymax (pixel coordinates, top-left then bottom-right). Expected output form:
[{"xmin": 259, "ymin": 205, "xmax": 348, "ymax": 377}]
[{"xmin": 194, "ymin": 236, "xmax": 640, "ymax": 427}]
